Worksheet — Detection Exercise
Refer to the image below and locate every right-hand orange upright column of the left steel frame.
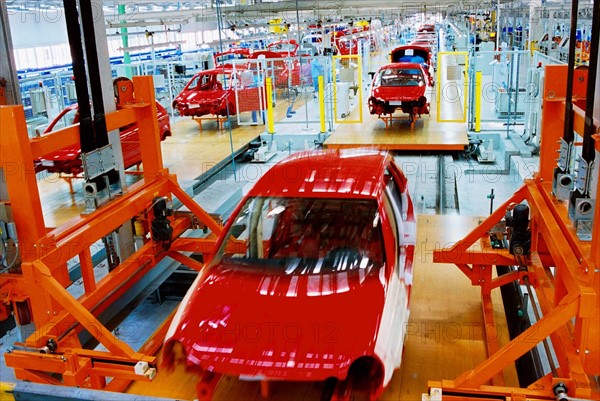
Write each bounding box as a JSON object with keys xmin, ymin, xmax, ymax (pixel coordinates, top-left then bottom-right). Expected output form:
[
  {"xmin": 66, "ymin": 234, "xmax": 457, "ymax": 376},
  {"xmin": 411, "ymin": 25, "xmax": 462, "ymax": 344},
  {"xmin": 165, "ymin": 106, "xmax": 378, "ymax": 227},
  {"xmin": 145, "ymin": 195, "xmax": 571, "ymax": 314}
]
[{"xmin": 133, "ymin": 76, "xmax": 163, "ymax": 181}]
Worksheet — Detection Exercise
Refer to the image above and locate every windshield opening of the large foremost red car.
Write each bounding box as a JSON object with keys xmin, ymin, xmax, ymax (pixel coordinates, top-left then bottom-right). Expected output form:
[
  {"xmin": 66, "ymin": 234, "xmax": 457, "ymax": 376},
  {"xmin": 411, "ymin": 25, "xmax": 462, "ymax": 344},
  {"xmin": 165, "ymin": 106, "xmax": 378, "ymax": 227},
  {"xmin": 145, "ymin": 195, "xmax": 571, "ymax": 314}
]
[{"xmin": 215, "ymin": 197, "xmax": 384, "ymax": 274}]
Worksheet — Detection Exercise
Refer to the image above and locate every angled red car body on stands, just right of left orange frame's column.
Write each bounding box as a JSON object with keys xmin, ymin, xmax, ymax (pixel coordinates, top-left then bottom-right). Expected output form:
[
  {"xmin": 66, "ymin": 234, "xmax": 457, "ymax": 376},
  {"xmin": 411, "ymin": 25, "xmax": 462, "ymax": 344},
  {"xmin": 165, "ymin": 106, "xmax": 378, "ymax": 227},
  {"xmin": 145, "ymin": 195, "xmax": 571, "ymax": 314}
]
[{"xmin": 173, "ymin": 67, "xmax": 265, "ymax": 117}]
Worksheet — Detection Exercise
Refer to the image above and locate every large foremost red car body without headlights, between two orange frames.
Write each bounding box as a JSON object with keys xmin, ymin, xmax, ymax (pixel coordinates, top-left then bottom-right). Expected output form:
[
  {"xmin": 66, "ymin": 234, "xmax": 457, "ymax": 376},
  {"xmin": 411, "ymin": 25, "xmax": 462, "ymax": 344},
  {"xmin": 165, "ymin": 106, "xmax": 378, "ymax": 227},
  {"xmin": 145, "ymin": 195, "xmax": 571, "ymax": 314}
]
[{"xmin": 163, "ymin": 150, "xmax": 416, "ymax": 395}]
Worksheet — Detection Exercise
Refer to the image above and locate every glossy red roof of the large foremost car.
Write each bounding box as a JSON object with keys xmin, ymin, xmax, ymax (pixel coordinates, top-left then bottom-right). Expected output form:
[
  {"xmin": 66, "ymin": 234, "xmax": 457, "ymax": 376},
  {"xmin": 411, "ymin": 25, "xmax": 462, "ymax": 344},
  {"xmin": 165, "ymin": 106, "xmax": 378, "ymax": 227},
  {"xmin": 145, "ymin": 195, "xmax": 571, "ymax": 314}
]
[{"xmin": 248, "ymin": 150, "xmax": 388, "ymax": 199}]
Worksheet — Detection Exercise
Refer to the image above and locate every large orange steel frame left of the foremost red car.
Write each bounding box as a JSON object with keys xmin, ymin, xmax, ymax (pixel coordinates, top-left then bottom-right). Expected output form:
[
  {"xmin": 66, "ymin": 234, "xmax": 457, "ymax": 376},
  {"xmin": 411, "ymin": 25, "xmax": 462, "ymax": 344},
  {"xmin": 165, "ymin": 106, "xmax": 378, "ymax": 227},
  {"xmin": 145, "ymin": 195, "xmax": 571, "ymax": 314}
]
[{"xmin": 0, "ymin": 77, "xmax": 222, "ymax": 391}]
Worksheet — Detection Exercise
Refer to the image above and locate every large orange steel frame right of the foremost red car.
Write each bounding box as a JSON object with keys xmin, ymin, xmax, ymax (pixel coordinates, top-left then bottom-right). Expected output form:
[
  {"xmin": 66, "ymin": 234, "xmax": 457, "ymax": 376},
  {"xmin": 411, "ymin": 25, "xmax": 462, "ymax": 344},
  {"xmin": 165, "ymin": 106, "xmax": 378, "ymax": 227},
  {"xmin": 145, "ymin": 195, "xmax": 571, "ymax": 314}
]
[{"xmin": 429, "ymin": 66, "xmax": 600, "ymax": 400}]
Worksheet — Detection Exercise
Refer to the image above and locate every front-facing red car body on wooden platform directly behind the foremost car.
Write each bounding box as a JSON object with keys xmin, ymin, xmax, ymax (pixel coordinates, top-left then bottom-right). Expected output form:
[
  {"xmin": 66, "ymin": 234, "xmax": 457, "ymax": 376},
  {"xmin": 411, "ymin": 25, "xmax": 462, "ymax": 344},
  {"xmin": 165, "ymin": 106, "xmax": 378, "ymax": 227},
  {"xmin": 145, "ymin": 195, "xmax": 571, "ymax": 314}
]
[{"xmin": 369, "ymin": 63, "xmax": 429, "ymax": 122}]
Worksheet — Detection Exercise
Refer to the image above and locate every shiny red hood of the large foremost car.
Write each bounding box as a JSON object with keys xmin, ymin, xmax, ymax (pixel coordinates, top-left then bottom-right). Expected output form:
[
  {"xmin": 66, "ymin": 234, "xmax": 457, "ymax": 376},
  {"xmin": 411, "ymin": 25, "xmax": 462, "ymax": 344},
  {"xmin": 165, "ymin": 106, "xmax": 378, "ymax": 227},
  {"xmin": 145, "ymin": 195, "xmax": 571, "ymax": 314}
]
[{"xmin": 167, "ymin": 264, "xmax": 384, "ymax": 380}]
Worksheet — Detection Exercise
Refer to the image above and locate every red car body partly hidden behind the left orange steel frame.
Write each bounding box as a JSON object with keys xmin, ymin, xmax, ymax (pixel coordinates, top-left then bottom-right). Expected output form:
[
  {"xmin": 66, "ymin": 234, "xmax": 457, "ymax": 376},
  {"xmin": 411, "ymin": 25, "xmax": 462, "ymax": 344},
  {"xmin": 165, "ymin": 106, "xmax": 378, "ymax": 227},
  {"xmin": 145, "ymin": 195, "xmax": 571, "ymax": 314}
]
[{"xmin": 34, "ymin": 102, "xmax": 171, "ymax": 176}]
